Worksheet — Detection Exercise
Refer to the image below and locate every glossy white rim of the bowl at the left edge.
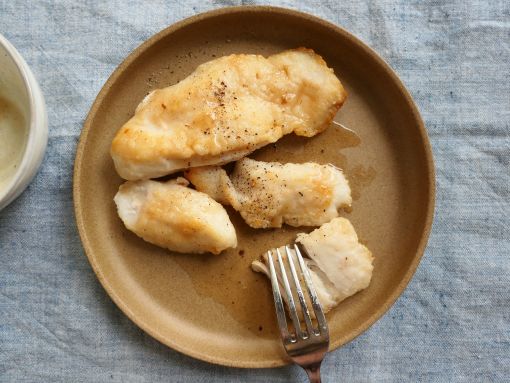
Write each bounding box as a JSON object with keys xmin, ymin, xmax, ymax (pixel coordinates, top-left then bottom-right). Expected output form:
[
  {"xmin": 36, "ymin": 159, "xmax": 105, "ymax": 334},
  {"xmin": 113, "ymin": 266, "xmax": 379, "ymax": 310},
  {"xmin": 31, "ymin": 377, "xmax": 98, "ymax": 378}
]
[{"xmin": 0, "ymin": 33, "xmax": 46, "ymax": 210}]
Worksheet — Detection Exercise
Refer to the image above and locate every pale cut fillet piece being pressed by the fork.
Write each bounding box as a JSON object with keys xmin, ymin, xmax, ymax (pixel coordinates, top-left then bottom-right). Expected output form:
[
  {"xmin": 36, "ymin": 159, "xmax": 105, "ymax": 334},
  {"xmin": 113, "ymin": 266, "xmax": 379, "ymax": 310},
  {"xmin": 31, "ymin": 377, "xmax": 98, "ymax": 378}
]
[{"xmin": 252, "ymin": 217, "xmax": 374, "ymax": 312}]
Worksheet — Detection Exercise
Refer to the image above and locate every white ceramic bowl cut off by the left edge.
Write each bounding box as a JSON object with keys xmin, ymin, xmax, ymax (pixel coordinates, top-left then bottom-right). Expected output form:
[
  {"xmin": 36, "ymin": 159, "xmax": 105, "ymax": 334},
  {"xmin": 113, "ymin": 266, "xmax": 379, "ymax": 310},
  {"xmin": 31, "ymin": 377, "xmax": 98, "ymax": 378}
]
[{"xmin": 0, "ymin": 34, "xmax": 48, "ymax": 210}]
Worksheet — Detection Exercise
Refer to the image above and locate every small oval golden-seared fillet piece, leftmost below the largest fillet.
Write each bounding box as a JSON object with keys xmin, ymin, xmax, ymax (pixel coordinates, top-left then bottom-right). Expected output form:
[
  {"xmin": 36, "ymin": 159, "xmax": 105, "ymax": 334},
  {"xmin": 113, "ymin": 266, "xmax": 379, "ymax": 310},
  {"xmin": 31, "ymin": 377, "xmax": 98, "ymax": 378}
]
[{"xmin": 114, "ymin": 178, "xmax": 237, "ymax": 254}]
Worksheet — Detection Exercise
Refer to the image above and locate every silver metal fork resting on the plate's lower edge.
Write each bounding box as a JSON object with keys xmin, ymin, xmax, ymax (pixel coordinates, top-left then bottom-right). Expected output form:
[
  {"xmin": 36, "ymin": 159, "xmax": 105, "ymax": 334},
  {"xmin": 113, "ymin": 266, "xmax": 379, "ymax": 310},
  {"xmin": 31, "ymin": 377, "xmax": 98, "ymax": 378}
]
[{"xmin": 267, "ymin": 244, "xmax": 329, "ymax": 383}]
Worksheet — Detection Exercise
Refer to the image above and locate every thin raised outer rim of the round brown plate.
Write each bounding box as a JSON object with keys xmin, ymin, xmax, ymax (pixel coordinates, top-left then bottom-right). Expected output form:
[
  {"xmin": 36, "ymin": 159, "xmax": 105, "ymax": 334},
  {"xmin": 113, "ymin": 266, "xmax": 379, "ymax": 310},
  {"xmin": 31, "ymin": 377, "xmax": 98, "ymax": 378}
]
[{"xmin": 73, "ymin": 5, "xmax": 436, "ymax": 368}]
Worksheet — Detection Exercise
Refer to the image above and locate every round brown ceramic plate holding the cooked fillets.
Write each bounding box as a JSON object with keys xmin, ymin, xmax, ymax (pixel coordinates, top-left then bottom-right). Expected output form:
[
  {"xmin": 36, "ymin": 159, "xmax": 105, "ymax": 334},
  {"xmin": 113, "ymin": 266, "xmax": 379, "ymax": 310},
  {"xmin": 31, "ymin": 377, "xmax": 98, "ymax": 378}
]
[{"xmin": 74, "ymin": 7, "xmax": 434, "ymax": 367}]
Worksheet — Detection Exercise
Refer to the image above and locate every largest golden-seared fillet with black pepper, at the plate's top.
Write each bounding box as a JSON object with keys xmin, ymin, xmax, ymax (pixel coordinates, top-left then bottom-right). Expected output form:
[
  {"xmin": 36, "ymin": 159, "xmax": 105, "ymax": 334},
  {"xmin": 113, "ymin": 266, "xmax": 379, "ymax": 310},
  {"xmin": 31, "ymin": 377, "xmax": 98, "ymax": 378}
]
[{"xmin": 111, "ymin": 48, "xmax": 346, "ymax": 180}]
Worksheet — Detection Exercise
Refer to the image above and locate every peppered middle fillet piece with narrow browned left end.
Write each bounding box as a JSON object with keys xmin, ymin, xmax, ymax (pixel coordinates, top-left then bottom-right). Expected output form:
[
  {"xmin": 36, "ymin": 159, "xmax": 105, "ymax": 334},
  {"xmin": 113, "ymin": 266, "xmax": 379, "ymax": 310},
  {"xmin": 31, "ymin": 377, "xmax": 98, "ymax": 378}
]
[{"xmin": 185, "ymin": 158, "xmax": 352, "ymax": 228}]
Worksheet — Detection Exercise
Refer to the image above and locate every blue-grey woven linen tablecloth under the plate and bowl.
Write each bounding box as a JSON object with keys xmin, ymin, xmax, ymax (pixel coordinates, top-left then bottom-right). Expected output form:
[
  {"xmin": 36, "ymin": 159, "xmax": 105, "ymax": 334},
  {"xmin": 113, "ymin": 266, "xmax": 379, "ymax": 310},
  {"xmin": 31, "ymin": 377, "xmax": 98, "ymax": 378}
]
[{"xmin": 0, "ymin": 0, "xmax": 510, "ymax": 382}]
